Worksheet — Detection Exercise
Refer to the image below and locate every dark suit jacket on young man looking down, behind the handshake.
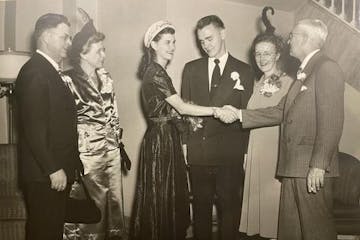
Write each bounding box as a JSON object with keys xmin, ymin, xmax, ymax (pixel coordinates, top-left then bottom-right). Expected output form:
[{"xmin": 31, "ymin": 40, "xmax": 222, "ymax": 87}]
[{"xmin": 181, "ymin": 54, "xmax": 254, "ymax": 165}]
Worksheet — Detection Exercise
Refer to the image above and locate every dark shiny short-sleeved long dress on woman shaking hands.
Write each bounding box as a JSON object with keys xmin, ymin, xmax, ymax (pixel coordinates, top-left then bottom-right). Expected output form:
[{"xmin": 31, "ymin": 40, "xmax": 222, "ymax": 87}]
[{"xmin": 130, "ymin": 62, "xmax": 189, "ymax": 240}]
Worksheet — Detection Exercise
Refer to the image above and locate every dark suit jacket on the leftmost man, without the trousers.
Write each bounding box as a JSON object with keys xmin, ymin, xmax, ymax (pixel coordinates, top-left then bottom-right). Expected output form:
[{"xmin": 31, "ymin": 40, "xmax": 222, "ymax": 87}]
[{"xmin": 15, "ymin": 53, "xmax": 81, "ymax": 182}]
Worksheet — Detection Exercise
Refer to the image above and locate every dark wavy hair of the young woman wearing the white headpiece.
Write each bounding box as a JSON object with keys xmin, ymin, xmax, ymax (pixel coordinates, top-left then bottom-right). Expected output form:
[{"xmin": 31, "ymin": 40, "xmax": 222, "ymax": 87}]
[{"xmin": 138, "ymin": 27, "xmax": 175, "ymax": 80}]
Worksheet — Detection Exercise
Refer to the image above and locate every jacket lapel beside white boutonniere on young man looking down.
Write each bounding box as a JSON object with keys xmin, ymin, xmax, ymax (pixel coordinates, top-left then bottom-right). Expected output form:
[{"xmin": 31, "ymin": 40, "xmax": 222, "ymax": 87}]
[{"xmin": 211, "ymin": 54, "xmax": 241, "ymax": 105}]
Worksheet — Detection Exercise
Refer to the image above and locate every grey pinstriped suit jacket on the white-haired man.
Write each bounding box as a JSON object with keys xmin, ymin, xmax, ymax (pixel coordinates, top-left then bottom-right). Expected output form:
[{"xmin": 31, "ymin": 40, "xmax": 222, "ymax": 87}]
[{"xmin": 242, "ymin": 52, "xmax": 344, "ymax": 177}]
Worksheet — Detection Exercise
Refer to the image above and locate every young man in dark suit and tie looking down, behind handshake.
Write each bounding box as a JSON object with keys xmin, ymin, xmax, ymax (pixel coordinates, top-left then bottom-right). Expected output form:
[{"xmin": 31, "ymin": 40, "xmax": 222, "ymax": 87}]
[{"xmin": 181, "ymin": 15, "xmax": 253, "ymax": 240}]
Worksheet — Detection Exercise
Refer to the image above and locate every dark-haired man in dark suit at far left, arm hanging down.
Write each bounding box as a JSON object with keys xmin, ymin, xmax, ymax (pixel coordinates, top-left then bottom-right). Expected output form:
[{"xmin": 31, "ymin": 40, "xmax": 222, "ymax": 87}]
[{"xmin": 16, "ymin": 13, "xmax": 81, "ymax": 240}]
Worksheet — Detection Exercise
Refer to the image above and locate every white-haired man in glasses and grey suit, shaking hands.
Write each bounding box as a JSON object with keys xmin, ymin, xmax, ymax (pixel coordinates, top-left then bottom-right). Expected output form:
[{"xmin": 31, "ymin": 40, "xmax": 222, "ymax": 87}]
[{"xmin": 222, "ymin": 19, "xmax": 344, "ymax": 240}]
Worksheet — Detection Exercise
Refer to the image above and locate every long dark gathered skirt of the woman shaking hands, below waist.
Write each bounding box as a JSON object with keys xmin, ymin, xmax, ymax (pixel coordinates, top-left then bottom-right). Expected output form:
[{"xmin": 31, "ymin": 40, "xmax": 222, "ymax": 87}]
[{"xmin": 129, "ymin": 121, "xmax": 190, "ymax": 240}]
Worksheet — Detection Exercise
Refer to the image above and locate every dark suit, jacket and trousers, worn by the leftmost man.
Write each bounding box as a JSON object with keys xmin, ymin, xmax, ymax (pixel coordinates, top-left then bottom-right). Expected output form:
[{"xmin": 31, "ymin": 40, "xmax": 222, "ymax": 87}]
[{"xmin": 16, "ymin": 53, "xmax": 81, "ymax": 239}]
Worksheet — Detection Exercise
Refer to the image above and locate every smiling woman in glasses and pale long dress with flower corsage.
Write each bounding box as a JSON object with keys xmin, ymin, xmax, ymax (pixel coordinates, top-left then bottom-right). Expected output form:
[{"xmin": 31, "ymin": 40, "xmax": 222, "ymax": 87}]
[{"xmin": 239, "ymin": 33, "xmax": 293, "ymax": 238}]
